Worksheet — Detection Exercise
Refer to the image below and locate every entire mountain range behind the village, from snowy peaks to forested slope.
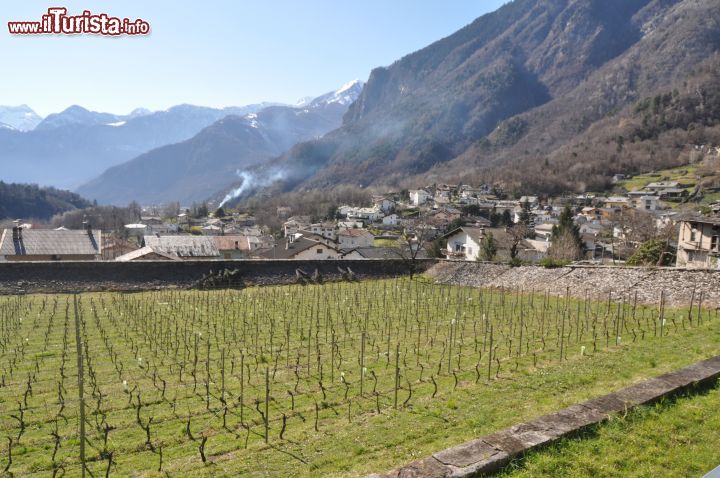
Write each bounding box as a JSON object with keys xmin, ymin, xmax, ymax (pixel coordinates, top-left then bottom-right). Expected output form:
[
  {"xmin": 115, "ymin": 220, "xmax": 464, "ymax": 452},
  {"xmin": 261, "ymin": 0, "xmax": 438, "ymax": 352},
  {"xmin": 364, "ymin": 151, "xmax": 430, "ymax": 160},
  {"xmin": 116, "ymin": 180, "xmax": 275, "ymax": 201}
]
[{"xmin": 7, "ymin": 0, "xmax": 720, "ymax": 209}]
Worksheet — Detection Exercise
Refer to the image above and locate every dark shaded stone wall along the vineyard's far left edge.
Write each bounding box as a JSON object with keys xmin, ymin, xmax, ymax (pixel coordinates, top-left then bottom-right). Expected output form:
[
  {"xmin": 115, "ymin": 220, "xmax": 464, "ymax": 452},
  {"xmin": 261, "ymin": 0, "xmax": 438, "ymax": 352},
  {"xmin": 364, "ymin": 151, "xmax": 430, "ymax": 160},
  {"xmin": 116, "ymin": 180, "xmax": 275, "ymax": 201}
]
[{"xmin": 0, "ymin": 259, "xmax": 436, "ymax": 294}]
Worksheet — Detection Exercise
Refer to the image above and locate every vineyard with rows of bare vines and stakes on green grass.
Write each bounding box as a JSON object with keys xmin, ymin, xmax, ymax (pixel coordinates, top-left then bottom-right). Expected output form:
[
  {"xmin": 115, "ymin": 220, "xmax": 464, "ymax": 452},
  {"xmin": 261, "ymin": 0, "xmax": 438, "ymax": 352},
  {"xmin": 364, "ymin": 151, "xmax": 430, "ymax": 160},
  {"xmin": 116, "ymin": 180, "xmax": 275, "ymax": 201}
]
[{"xmin": 0, "ymin": 279, "xmax": 717, "ymax": 476}]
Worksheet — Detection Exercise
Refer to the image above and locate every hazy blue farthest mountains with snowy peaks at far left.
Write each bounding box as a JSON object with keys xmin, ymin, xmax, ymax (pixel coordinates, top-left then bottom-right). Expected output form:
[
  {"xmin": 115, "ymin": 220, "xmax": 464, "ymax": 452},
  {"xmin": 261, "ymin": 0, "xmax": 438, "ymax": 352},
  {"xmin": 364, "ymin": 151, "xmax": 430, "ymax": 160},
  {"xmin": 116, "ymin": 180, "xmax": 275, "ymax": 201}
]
[{"xmin": 0, "ymin": 103, "xmax": 282, "ymax": 188}]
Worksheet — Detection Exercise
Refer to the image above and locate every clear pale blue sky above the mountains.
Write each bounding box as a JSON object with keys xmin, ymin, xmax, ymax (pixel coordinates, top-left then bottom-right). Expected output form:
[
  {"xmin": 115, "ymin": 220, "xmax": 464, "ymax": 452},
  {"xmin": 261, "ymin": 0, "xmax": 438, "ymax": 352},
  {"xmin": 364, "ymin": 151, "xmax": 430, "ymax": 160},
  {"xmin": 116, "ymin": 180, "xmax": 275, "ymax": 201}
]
[{"xmin": 0, "ymin": 0, "xmax": 505, "ymax": 116}]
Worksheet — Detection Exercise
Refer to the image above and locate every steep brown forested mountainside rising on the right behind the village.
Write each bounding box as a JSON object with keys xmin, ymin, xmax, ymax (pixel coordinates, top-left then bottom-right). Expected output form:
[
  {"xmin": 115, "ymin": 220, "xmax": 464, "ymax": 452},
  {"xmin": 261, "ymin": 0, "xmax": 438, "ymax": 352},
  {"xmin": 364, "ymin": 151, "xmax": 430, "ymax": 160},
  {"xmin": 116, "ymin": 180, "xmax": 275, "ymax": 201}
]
[{"xmin": 225, "ymin": 0, "xmax": 720, "ymax": 200}]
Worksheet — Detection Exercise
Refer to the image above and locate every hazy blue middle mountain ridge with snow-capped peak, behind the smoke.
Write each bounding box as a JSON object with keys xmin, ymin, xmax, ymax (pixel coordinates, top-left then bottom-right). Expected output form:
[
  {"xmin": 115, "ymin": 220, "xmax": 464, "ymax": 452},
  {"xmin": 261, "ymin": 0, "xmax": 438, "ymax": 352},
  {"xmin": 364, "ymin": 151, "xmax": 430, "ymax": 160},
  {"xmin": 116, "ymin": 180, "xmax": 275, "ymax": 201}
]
[{"xmin": 77, "ymin": 80, "xmax": 363, "ymax": 204}]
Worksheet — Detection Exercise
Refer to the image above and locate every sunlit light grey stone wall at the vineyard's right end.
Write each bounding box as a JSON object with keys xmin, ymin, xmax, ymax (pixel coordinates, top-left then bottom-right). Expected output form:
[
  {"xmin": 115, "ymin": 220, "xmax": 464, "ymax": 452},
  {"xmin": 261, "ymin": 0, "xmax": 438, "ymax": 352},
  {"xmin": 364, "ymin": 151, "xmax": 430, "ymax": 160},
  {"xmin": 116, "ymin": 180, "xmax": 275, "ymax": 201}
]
[{"xmin": 428, "ymin": 262, "xmax": 720, "ymax": 307}]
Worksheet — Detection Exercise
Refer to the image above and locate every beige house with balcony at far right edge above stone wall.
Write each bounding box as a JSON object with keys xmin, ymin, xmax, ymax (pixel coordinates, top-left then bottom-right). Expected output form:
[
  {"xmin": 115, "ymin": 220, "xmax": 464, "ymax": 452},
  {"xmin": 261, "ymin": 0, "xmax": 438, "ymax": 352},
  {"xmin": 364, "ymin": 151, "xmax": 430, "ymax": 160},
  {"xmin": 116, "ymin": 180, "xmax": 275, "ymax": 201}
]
[{"xmin": 677, "ymin": 216, "xmax": 720, "ymax": 269}]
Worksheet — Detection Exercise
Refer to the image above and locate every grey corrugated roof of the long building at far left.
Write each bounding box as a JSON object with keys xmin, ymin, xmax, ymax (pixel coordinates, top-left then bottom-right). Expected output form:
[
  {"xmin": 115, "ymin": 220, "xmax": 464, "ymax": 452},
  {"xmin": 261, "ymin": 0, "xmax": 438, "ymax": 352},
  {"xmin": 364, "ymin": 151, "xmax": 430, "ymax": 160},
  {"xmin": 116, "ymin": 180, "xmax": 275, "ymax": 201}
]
[{"xmin": 0, "ymin": 229, "xmax": 102, "ymax": 256}]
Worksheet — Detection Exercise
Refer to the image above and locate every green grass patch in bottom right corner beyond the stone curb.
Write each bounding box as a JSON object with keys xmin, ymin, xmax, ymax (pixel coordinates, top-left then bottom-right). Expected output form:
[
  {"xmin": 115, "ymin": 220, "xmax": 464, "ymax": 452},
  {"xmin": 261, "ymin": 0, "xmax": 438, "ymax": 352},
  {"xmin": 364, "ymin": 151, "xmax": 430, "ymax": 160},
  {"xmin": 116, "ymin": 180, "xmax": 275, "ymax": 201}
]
[{"xmin": 500, "ymin": 380, "xmax": 720, "ymax": 478}]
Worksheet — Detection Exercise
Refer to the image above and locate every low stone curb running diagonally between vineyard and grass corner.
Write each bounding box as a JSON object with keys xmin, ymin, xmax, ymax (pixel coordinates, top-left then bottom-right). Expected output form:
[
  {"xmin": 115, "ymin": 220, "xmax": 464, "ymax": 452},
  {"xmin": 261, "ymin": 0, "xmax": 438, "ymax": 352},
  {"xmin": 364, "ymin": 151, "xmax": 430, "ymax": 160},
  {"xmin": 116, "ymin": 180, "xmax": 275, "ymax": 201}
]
[{"xmin": 368, "ymin": 356, "xmax": 720, "ymax": 478}]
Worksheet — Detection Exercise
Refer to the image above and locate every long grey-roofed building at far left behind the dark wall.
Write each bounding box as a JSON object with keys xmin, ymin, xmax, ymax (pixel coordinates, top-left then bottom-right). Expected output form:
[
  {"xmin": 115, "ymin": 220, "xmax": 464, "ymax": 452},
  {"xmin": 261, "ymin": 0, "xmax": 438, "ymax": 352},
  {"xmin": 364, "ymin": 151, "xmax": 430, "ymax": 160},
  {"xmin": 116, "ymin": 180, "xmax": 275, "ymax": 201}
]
[{"xmin": 0, "ymin": 223, "xmax": 102, "ymax": 261}]
